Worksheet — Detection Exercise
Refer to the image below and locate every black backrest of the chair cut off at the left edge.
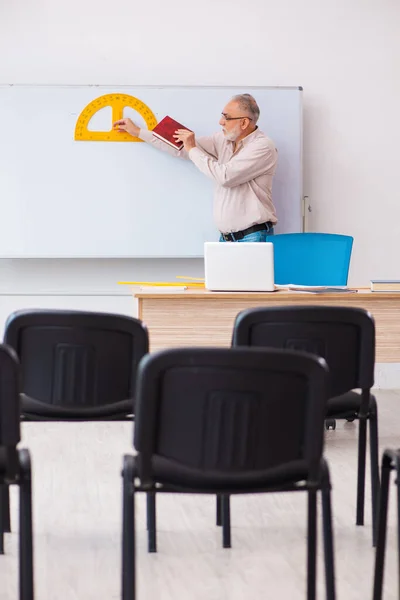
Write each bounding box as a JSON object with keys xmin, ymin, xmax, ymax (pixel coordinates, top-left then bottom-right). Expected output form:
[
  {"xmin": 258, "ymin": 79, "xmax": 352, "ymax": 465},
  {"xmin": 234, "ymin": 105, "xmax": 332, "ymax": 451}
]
[{"xmin": 0, "ymin": 344, "xmax": 21, "ymax": 479}]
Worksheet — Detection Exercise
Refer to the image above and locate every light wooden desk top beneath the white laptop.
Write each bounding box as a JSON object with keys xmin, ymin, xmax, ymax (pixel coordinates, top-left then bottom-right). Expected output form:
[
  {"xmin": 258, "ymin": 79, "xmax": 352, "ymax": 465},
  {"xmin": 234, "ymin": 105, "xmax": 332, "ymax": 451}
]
[{"xmin": 133, "ymin": 287, "xmax": 400, "ymax": 301}]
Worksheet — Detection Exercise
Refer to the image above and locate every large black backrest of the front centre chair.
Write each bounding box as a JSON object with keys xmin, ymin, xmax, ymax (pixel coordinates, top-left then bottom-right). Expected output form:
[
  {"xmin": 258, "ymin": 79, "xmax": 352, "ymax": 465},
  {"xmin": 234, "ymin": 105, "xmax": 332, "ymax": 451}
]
[{"xmin": 134, "ymin": 348, "xmax": 327, "ymax": 483}]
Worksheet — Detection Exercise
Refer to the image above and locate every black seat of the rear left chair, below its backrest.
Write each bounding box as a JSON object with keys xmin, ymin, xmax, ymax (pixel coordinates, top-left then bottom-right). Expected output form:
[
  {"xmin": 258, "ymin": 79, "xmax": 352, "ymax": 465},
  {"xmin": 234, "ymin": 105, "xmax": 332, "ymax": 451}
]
[{"xmin": 21, "ymin": 394, "xmax": 133, "ymax": 421}]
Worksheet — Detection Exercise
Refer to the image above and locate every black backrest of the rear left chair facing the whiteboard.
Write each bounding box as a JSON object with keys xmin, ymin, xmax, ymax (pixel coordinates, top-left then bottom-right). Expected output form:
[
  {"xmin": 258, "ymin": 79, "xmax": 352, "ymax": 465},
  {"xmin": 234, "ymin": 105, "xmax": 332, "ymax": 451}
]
[{"xmin": 4, "ymin": 310, "xmax": 148, "ymax": 416}]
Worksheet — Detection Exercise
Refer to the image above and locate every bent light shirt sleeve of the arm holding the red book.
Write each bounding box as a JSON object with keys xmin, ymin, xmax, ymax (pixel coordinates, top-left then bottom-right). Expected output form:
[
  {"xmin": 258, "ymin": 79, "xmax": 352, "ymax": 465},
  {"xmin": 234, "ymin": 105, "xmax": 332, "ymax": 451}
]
[{"xmin": 189, "ymin": 143, "xmax": 276, "ymax": 188}]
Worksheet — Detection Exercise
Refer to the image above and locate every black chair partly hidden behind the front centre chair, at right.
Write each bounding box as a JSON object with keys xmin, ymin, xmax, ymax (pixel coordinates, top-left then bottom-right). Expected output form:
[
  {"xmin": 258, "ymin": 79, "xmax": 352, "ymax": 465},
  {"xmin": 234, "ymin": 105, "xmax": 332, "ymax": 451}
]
[{"xmin": 231, "ymin": 306, "xmax": 379, "ymax": 545}]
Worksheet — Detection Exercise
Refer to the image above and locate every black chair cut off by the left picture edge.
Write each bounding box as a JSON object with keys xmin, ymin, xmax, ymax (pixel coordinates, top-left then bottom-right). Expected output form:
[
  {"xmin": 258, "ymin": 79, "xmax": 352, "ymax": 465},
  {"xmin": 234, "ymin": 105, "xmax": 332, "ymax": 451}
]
[{"xmin": 0, "ymin": 345, "xmax": 34, "ymax": 600}]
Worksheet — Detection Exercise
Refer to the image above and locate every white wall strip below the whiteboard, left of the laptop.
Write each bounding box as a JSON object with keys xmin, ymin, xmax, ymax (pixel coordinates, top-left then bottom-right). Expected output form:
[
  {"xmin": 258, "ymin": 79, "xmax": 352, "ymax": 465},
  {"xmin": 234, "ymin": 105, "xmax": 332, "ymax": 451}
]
[{"xmin": 0, "ymin": 259, "xmax": 204, "ymax": 332}]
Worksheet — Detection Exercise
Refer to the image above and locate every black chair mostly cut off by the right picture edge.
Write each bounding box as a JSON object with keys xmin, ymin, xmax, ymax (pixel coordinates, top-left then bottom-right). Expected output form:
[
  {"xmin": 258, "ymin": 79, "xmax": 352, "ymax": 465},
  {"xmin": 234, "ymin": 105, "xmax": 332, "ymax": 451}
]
[{"xmin": 373, "ymin": 449, "xmax": 400, "ymax": 600}]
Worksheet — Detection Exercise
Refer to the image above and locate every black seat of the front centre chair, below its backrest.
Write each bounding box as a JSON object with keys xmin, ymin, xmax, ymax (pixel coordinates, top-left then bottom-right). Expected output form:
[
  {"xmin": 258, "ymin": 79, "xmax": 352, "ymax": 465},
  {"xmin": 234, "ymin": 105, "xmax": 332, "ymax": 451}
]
[{"xmin": 134, "ymin": 456, "xmax": 308, "ymax": 493}]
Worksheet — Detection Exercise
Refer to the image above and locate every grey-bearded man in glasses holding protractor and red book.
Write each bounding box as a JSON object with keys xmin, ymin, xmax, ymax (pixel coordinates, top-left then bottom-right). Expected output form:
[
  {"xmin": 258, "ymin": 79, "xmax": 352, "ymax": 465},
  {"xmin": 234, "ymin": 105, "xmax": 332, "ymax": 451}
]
[{"xmin": 114, "ymin": 94, "xmax": 277, "ymax": 242}]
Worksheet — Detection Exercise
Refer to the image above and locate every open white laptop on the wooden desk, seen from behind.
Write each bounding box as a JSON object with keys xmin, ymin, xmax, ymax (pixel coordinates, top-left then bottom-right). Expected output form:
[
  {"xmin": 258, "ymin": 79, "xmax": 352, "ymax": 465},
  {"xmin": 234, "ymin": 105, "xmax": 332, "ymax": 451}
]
[{"xmin": 204, "ymin": 242, "xmax": 275, "ymax": 292}]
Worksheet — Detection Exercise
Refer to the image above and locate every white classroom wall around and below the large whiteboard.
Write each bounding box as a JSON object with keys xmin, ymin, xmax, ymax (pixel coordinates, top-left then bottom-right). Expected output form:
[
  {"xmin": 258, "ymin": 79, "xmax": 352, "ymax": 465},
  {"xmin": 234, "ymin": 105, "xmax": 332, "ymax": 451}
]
[{"xmin": 0, "ymin": 0, "xmax": 400, "ymax": 384}]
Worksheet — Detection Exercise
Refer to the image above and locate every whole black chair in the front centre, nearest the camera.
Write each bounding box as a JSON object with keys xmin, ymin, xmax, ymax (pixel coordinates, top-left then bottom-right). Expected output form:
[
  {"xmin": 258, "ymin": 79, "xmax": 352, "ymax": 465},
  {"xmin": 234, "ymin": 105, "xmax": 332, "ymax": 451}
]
[{"xmin": 122, "ymin": 348, "xmax": 335, "ymax": 600}]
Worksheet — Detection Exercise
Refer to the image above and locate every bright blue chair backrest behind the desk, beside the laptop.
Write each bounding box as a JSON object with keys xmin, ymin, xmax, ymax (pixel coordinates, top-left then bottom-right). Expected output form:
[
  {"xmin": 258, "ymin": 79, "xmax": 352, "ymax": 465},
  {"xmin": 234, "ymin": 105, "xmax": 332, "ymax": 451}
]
[{"xmin": 268, "ymin": 233, "xmax": 353, "ymax": 286}]
